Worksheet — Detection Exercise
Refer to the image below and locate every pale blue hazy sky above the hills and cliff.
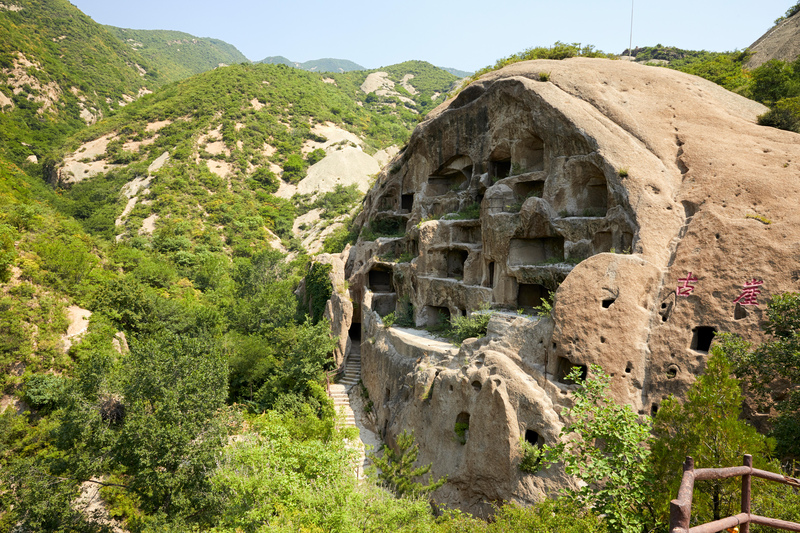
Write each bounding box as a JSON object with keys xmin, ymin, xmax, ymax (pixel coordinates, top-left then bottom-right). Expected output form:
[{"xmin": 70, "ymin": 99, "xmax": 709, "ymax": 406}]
[{"xmin": 71, "ymin": 0, "xmax": 795, "ymax": 70}]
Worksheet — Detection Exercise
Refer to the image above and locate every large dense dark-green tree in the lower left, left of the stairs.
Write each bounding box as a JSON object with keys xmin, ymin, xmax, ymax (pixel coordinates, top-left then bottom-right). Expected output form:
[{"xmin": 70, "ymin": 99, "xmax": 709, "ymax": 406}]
[{"xmin": 50, "ymin": 333, "xmax": 234, "ymax": 521}]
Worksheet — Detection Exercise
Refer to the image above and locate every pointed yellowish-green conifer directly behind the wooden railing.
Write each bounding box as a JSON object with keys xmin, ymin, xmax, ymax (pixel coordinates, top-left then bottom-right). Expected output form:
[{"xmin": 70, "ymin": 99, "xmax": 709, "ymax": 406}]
[{"xmin": 652, "ymin": 350, "xmax": 773, "ymax": 523}]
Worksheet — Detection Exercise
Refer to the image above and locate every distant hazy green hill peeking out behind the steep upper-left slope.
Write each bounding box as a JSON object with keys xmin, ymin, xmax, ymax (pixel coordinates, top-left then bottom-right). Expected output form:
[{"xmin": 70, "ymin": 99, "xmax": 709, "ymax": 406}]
[{"xmin": 105, "ymin": 26, "xmax": 249, "ymax": 81}]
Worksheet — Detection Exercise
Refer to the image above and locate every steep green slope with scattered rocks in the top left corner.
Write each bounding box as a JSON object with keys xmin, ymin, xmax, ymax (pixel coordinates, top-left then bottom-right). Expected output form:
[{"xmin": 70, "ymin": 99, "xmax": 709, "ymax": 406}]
[{"xmin": 0, "ymin": 0, "xmax": 163, "ymax": 164}]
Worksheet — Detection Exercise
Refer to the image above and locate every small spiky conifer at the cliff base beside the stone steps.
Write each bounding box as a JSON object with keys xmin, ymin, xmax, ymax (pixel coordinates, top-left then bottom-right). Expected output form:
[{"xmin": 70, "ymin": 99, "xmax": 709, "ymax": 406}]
[{"xmin": 372, "ymin": 431, "xmax": 447, "ymax": 497}]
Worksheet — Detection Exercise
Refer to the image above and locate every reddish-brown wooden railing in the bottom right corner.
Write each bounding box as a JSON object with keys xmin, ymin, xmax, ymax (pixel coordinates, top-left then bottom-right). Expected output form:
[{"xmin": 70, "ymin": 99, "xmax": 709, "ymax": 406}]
[{"xmin": 669, "ymin": 455, "xmax": 800, "ymax": 533}]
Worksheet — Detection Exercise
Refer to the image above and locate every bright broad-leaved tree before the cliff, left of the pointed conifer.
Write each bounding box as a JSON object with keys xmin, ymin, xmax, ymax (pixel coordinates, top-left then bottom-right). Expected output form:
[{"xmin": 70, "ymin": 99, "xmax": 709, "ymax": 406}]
[{"xmin": 540, "ymin": 365, "xmax": 650, "ymax": 533}]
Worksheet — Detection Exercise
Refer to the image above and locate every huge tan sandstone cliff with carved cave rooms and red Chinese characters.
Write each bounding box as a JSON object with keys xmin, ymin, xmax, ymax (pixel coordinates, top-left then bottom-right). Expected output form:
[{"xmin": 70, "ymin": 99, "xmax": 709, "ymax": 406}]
[{"xmin": 330, "ymin": 58, "xmax": 800, "ymax": 513}]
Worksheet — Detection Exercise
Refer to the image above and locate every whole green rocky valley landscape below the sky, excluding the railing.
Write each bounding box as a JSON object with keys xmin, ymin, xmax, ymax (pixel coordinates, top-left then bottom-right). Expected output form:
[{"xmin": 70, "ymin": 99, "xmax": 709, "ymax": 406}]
[{"xmin": 0, "ymin": 0, "xmax": 800, "ymax": 533}]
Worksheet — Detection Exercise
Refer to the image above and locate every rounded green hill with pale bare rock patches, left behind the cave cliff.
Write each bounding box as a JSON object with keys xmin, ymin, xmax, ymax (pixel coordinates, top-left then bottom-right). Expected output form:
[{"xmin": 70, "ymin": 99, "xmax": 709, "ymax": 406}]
[{"xmin": 47, "ymin": 62, "xmax": 455, "ymax": 256}]
